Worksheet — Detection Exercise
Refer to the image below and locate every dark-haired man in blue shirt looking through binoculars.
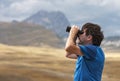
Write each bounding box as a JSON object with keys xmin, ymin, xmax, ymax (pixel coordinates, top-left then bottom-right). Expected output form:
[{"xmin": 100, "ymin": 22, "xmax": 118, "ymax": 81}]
[{"xmin": 65, "ymin": 23, "xmax": 105, "ymax": 81}]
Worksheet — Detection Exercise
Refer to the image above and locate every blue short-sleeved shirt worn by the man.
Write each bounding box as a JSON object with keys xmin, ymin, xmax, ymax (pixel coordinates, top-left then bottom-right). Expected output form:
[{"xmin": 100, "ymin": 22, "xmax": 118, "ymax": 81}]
[{"xmin": 74, "ymin": 45, "xmax": 105, "ymax": 81}]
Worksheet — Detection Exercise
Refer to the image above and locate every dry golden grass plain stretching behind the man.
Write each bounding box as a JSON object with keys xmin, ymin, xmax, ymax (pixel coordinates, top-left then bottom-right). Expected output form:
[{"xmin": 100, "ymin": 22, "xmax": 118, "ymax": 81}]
[{"xmin": 0, "ymin": 44, "xmax": 120, "ymax": 81}]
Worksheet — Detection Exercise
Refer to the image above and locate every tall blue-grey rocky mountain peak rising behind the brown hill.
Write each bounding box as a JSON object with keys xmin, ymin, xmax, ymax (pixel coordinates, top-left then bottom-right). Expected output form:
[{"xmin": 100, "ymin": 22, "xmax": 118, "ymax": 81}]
[{"xmin": 22, "ymin": 10, "xmax": 70, "ymax": 38}]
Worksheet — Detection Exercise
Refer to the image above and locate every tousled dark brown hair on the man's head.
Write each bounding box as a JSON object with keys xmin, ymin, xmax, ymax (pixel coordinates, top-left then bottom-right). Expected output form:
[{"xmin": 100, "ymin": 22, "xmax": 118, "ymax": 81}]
[{"xmin": 82, "ymin": 23, "xmax": 104, "ymax": 46}]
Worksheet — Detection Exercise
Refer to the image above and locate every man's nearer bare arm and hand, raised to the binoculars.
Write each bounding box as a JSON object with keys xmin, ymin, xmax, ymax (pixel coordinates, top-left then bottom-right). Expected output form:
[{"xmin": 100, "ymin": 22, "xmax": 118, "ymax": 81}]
[{"xmin": 65, "ymin": 26, "xmax": 83, "ymax": 55}]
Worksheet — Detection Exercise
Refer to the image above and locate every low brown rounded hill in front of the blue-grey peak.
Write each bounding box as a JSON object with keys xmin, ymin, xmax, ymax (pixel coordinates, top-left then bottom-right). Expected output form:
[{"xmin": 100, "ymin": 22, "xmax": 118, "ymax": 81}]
[{"xmin": 0, "ymin": 22, "xmax": 64, "ymax": 47}]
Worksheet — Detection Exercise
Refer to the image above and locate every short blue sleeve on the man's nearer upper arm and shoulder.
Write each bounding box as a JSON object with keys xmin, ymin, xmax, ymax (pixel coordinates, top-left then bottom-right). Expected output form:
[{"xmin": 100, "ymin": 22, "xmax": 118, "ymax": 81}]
[{"xmin": 79, "ymin": 45, "xmax": 97, "ymax": 60}]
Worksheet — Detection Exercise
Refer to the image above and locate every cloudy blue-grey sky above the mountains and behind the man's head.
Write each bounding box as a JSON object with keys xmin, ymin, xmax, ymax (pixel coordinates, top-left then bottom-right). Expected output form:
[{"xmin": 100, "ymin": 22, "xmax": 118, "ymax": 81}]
[{"xmin": 0, "ymin": 0, "xmax": 120, "ymax": 35}]
